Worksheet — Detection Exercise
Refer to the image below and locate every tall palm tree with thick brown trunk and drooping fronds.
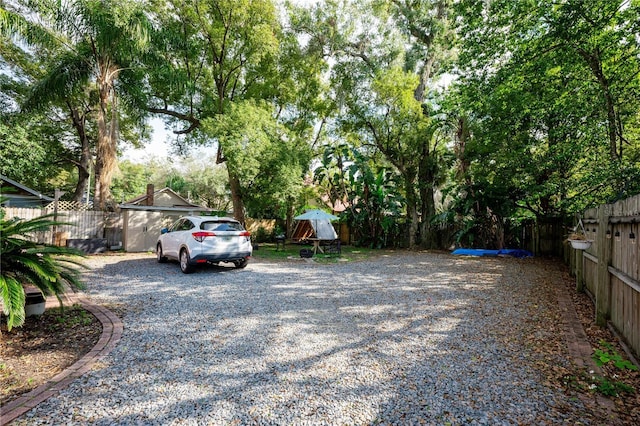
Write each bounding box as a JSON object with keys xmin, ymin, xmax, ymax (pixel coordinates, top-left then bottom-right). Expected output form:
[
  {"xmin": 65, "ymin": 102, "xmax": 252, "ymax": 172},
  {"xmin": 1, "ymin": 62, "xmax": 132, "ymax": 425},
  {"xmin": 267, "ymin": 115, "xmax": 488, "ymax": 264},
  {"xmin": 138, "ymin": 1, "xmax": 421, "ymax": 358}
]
[{"xmin": 0, "ymin": 0, "xmax": 150, "ymax": 209}]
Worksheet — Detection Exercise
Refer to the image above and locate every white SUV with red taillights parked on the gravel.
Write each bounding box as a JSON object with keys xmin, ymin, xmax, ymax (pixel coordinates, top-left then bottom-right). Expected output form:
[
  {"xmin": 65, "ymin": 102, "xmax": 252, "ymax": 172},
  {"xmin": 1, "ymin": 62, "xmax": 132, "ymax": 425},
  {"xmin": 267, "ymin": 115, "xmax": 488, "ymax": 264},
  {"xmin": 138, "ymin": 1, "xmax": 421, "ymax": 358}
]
[{"xmin": 156, "ymin": 216, "xmax": 253, "ymax": 274}]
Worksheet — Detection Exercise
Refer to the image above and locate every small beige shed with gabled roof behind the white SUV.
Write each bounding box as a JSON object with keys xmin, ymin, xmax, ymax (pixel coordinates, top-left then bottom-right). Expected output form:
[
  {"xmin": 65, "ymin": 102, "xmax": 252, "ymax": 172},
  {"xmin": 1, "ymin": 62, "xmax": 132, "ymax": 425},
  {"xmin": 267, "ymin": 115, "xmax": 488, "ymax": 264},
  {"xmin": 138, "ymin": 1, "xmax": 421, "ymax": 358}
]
[{"xmin": 119, "ymin": 185, "xmax": 211, "ymax": 252}]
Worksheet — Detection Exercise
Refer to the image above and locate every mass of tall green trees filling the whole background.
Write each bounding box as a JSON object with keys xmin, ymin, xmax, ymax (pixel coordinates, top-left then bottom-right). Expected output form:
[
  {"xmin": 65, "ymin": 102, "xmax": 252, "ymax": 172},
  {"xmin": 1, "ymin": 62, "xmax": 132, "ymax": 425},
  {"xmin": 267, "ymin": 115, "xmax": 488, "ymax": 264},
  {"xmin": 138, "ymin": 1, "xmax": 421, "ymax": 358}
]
[{"xmin": 0, "ymin": 0, "xmax": 640, "ymax": 248}]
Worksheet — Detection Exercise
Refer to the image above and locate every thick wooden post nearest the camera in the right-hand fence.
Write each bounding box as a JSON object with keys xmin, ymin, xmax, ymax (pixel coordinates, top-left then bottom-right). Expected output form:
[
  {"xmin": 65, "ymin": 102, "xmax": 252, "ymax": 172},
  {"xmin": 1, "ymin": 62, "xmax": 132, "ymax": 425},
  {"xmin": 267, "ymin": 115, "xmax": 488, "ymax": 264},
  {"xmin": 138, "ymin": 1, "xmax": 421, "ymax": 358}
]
[{"xmin": 595, "ymin": 204, "xmax": 611, "ymax": 327}]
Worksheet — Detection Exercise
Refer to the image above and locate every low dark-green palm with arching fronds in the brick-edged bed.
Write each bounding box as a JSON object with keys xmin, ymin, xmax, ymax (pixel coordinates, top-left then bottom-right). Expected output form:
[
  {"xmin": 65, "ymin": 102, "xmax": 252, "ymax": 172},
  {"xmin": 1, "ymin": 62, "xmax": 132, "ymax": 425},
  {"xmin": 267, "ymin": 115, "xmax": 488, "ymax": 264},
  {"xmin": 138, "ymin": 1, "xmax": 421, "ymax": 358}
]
[{"xmin": 0, "ymin": 198, "xmax": 84, "ymax": 330}]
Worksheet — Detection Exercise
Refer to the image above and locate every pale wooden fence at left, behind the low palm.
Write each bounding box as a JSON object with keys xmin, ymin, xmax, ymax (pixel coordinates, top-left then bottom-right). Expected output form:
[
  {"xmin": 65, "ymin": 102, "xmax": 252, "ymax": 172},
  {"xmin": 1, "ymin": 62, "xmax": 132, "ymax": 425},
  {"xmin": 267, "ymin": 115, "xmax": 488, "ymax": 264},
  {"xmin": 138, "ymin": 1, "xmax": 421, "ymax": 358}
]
[{"xmin": 4, "ymin": 207, "xmax": 122, "ymax": 247}]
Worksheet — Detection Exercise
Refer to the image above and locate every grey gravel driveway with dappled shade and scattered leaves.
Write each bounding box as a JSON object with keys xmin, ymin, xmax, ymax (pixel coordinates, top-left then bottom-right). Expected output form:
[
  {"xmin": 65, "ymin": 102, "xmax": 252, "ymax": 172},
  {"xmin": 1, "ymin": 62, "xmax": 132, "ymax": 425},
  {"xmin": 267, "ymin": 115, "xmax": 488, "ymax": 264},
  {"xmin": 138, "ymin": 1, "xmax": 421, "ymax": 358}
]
[{"xmin": 16, "ymin": 253, "xmax": 589, "ymax": 425}]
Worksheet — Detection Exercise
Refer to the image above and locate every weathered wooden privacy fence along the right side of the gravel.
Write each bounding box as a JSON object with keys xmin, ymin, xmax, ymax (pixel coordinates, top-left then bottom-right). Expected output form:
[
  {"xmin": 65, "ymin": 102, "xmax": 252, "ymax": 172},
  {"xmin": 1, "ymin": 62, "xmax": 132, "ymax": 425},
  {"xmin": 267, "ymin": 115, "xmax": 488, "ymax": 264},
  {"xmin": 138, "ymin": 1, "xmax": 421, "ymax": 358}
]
[{"xmin": 569, "ymin": 195, "xmax": 640, "ymax": 355}]
